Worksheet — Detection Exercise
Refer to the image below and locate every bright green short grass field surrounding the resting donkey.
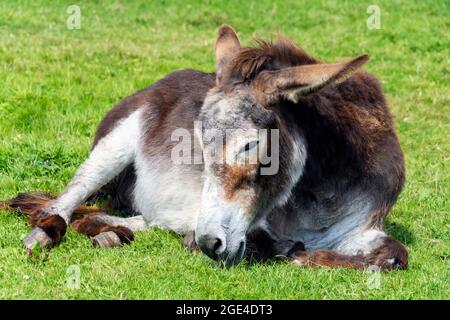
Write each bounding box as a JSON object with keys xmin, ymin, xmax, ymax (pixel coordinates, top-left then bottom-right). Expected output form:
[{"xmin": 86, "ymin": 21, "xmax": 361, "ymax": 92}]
[{"xmin": 0, "ymin": 0, "xmax": 450, "ymax": 299}]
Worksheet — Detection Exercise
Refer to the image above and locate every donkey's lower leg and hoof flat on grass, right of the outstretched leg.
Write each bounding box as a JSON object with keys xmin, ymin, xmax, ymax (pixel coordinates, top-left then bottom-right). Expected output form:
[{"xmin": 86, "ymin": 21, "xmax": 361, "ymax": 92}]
[{"xmin": 71, "ymin": 214, "xmax": 148, "ymax": 248}]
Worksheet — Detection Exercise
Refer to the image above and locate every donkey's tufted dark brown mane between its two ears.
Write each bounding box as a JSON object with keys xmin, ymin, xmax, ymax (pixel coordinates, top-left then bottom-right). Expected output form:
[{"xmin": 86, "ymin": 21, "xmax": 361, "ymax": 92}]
[{"xmin": 228, "ymin": 34, "xmax": 319, "ymax": 80}]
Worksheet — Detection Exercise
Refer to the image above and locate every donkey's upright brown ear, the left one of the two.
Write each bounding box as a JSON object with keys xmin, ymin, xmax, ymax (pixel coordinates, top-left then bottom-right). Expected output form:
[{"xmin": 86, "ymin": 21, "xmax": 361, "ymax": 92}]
[{"xmin": 216, "ymin": 25, "xmax": 241, "ymax": 82}]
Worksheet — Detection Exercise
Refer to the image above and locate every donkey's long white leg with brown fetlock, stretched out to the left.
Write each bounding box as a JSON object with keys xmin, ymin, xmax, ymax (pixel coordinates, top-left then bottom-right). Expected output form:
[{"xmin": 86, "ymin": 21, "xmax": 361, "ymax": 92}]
[{"xmin": 24, "ymin": 111, "xmax": 140, "ymax": 250}]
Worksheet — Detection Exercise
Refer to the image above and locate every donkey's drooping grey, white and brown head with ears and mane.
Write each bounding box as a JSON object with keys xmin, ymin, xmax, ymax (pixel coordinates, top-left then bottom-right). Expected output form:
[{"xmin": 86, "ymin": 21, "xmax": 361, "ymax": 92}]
[{"xmin": 196, "ymin": 26, "xmax": 368, "ymax": 264}]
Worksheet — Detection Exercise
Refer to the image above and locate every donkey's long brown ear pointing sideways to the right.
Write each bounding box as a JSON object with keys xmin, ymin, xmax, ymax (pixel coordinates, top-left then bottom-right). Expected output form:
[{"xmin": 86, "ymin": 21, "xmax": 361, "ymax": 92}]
[{"xmin": 253, "ymin": 55, "xmax": 369, "ymax": 103}]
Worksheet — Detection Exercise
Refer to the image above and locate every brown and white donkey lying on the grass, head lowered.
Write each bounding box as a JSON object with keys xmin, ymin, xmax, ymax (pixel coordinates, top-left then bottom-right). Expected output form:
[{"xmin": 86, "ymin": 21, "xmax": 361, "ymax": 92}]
[{"xmin": 3, "ymin": 25, "xmax": 408, "ymax": 270}]
